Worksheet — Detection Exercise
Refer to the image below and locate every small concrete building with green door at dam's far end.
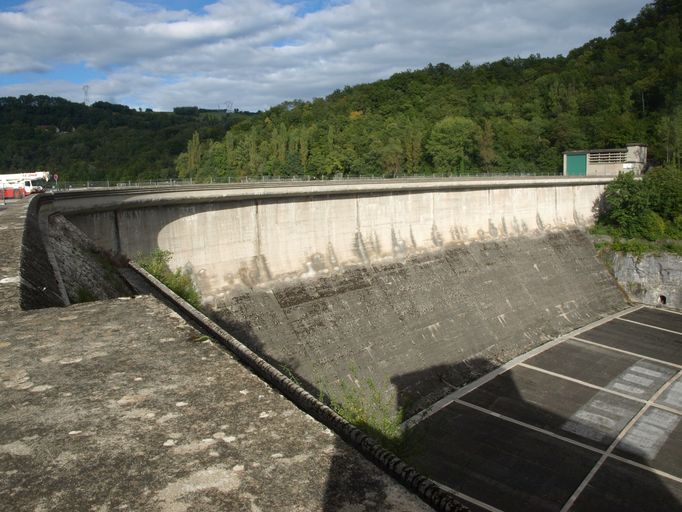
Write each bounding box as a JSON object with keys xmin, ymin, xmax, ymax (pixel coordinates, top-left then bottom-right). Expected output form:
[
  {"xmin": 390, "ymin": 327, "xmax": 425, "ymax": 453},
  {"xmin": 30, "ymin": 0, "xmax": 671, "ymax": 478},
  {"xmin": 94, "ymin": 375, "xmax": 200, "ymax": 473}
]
[{"xmin": 564, "ymin": 144, "xmax": 647, "ymax": 176}]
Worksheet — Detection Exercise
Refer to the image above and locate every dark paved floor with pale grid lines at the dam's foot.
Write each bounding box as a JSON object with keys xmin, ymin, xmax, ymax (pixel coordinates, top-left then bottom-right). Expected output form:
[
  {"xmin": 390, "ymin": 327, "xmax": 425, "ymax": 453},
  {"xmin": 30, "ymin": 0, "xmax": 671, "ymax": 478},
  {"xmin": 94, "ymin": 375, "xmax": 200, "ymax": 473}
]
[{"xmin": 412, "ymin": 308, "xmax": 682, "ymax": 512}]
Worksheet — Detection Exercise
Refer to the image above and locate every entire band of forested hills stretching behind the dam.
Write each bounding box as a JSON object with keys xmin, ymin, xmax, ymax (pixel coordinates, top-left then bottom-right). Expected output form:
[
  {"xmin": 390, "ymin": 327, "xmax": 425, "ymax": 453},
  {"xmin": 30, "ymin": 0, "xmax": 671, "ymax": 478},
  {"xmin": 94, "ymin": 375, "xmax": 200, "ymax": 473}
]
[{"xmin": 0, "ymin": 0, "xmax": 682, "ymax": 180}]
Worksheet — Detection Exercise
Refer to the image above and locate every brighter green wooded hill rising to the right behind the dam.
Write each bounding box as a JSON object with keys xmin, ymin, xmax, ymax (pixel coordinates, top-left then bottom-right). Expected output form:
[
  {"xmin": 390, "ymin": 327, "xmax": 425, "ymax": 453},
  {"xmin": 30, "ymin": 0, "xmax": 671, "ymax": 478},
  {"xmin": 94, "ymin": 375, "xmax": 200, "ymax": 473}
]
[{"xmin": 177, "ymin": 0, "xmax": 682, "ymax": 179}]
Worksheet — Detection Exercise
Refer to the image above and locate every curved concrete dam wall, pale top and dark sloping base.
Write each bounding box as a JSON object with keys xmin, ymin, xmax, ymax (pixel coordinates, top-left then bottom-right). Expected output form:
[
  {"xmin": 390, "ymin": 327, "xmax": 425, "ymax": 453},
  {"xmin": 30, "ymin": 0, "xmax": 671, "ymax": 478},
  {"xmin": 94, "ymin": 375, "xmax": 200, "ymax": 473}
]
[{"xmin": 25, "ymin": 178, "xmax": 625, "ymax": 416}]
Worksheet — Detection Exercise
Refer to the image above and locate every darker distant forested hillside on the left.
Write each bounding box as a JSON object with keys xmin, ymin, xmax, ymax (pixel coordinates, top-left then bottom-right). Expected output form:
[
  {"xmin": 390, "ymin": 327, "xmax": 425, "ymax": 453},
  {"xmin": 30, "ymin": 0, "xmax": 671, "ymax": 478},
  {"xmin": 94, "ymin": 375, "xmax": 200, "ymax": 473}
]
[{"xmin": 0, "ymin": 95, "xmax": 254, "ymax": 180}]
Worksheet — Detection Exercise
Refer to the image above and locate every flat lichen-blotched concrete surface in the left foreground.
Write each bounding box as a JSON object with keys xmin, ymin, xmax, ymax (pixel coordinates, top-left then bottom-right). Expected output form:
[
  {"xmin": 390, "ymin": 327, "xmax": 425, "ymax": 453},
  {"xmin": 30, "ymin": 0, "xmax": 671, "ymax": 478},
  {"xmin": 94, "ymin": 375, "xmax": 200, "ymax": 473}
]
[{"xmin": 0, "ymin": 202, "xmax": 429, "ymax": 512}]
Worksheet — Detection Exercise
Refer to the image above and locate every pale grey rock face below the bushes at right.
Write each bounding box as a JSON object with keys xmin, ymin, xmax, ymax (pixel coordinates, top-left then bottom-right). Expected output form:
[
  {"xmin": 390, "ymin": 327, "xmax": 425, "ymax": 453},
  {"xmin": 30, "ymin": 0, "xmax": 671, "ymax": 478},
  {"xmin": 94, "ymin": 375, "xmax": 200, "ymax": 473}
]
[{"xmin": 611, "ymin": 253, "xmax": 682, "ymax": 309}]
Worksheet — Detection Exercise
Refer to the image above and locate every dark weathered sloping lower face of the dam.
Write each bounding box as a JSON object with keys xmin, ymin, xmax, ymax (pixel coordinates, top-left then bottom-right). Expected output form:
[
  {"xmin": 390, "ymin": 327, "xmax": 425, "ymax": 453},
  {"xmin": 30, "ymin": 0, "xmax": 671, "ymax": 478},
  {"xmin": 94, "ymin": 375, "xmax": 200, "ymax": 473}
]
[{"xmin": 213, "ymin": 230, "xmax": 626, "ymax": 414}]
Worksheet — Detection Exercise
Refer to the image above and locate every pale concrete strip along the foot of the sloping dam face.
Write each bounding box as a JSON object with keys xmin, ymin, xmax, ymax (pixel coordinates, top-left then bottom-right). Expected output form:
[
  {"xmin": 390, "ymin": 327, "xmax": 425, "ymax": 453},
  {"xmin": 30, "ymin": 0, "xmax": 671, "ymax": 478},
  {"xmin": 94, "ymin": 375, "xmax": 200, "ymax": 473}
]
[{"xmin": 400, "ymin": 305, "xmax": 645, "ymax": 431}]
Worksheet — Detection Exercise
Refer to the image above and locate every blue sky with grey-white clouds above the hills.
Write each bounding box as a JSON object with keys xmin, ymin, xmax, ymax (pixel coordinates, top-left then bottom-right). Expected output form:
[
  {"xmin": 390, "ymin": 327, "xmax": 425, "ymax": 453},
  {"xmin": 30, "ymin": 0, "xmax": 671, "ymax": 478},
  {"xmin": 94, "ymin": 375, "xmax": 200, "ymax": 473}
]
[{"xmin": 0, "ymin": 0, "xmax": 645, "ymax": 110}]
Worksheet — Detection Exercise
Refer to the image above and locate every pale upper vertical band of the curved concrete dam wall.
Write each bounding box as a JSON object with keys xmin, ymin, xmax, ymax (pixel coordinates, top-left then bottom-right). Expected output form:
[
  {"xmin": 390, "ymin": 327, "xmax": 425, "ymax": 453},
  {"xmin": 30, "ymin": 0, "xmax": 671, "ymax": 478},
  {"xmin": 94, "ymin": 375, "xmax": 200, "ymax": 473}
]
[{"xmin": 64, "ymin": 178, "xmax": 608, "ymax": 300}]
